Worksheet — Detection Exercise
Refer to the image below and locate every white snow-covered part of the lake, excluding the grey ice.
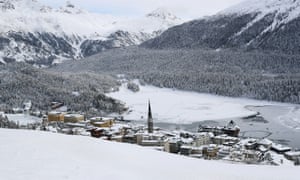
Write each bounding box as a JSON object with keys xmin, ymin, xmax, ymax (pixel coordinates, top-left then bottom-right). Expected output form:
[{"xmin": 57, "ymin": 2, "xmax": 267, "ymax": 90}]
[{"xmin": 108, "ymin": 84, "xmax": 278, "ymax": 124}]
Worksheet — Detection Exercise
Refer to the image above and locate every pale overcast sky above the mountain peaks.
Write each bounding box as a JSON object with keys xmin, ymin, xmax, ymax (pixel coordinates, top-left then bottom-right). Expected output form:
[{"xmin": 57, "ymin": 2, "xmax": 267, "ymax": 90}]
[{"xmin": 40, "ymin": 0, "xmax": 243, "ymax": 19}]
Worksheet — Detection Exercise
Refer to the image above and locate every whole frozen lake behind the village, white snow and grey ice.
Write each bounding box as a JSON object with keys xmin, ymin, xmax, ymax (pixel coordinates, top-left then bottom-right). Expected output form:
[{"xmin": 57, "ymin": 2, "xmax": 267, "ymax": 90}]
[{"xmin": 108, "ymin": 82, "xmax": 300, "ymax": 148}]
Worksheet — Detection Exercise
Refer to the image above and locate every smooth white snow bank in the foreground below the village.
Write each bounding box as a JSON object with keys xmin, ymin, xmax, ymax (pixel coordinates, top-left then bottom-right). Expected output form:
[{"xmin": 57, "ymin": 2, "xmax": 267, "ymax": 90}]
[{"xmin": 0, "ymin": 129, "xmax": 300, "ymax": 180}]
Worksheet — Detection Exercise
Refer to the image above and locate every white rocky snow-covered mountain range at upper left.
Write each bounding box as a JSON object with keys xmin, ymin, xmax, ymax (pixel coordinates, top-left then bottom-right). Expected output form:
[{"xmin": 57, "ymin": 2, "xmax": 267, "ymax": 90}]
[{"xmin": 0, "ymin": 0, "xmax": 182, "ymax": 65}]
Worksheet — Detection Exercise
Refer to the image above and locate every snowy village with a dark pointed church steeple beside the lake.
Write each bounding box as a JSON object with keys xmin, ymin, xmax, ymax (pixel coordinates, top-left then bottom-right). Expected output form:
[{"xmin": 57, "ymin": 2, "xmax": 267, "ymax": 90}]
[{"xmin": 0, "ymin": 101, "xmax": 300, "ymax": 165}]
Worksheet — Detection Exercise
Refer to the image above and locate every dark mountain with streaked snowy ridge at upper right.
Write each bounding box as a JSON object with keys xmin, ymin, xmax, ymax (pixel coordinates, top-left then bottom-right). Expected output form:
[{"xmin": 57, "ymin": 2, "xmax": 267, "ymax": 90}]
[{"xmin": 144, "ymin": 0, "xmax": 300, "ymax": 54}]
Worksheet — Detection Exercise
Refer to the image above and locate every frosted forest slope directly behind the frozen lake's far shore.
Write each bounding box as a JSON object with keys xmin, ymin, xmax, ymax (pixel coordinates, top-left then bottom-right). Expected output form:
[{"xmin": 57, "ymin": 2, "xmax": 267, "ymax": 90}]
[{"xmin": 49, "ymin": 47, "xmax": 300, "ymax": 103}]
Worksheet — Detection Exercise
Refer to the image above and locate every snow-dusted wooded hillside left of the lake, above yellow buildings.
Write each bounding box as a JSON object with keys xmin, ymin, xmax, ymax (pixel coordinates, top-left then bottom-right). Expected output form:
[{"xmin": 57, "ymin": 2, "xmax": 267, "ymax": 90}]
[{"xmin": 0, "ymin": 63, "xmax": 124, "ymax": 114}]
